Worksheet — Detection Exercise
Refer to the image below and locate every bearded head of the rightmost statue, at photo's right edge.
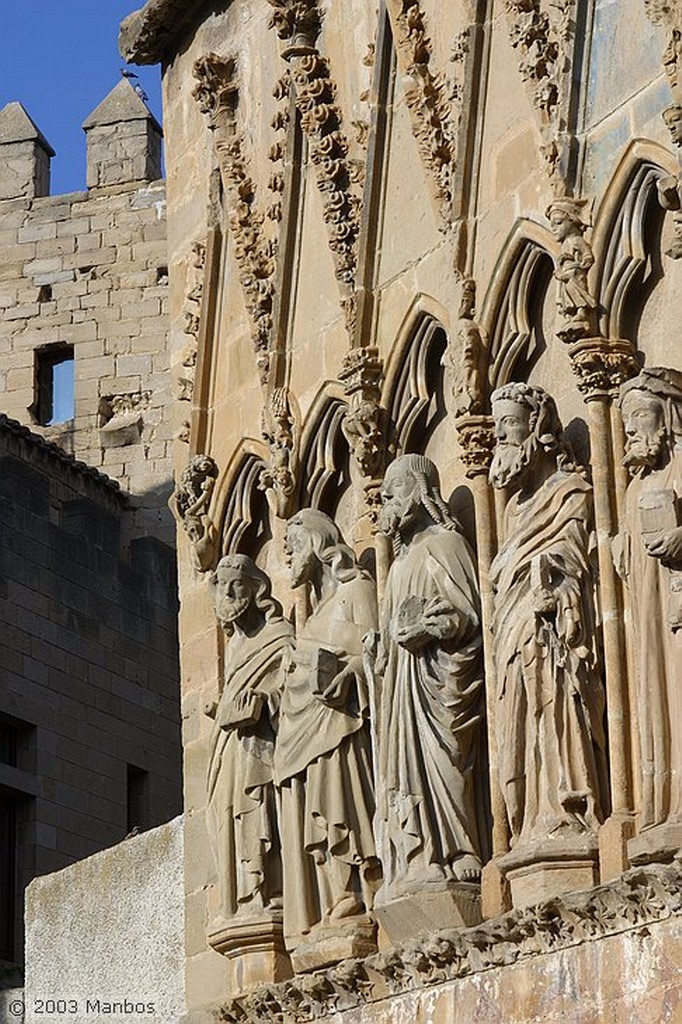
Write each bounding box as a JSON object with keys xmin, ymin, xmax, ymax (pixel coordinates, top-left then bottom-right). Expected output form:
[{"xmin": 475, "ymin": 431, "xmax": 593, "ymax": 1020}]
[{"xmin": 619, "ymin": 367, "xmax": 682, "ymax": 476}]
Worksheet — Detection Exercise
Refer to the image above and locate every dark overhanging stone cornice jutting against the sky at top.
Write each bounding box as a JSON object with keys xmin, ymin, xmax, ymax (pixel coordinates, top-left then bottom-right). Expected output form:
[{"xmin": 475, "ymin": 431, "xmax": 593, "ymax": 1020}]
[{"xmin": 119, "ymin": 0, "xmax": 212, "ymax": 65}]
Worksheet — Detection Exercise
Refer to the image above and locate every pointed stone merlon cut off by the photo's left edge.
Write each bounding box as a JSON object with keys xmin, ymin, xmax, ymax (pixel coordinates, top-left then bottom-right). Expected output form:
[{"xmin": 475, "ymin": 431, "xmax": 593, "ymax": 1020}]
[{"xmin": 0, "ymin": 102, "xmax": 54, "ymax": 200}]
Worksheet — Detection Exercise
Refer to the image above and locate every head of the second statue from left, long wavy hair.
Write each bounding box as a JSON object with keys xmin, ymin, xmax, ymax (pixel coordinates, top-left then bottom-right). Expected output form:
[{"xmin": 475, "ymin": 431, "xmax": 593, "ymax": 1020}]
[{"xmin": 285, "ymin": 509, "xmax": 363, "ymax": 587}]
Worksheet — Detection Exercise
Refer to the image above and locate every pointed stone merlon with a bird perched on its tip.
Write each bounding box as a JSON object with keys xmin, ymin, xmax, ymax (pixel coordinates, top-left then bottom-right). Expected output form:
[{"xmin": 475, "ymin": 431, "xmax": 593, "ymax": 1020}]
[{"xmin": 83, "ymin": 78, "xmax": 162, "ymax": 188}]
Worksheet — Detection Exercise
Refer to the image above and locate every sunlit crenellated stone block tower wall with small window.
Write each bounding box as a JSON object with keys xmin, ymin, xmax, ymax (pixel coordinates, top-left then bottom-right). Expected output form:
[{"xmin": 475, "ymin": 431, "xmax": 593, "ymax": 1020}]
[{"xmin": 0, "ymin": 80, "xmax": 174, "ymax": 544}]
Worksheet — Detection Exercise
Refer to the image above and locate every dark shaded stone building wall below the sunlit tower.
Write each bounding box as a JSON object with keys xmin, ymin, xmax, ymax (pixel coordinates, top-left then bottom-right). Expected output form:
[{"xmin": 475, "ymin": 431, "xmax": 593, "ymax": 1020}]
[{"xmin": 0, "ymin": 416, "xmax": 181, "ymax": 962}]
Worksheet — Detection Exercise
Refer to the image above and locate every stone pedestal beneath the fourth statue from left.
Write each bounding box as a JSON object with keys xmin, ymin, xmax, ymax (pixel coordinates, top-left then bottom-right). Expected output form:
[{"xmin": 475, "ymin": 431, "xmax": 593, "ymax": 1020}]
[{"xmin": 498, "ymin": 837, "xmax": 599, "ymax": 908}]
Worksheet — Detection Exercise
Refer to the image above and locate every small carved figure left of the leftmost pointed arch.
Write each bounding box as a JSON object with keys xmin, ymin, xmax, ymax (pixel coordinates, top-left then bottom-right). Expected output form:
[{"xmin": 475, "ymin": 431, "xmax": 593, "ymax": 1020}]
[{"xmin": 170, "ymin": 455, "xmax": 218, "ymax": 572}]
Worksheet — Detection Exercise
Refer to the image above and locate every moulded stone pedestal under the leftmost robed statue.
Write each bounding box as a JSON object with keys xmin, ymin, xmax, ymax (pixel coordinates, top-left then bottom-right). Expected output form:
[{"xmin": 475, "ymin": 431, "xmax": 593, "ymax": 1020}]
[{"xmin": 207, "ymin": 915, "xmax": 293, "ymax": 992}]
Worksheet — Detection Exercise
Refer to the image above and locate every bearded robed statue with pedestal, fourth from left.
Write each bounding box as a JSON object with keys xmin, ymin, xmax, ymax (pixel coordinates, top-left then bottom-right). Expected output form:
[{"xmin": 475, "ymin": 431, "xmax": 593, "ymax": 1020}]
[{"xmin": 491, "ymin": 383, "xmax": 607, "ymax": 905}]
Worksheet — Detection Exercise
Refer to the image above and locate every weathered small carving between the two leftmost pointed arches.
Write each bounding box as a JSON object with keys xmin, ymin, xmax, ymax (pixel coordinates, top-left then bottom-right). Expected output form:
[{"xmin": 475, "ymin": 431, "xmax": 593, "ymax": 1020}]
[{"xmin": 258, "ymin": 387, "xmax": 297, "ymax": 519}]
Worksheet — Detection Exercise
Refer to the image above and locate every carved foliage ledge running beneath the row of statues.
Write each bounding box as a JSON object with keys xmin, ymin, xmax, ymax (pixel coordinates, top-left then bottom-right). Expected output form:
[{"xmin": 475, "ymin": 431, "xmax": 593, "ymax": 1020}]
[{"xmin": 215, "ymin": 862, "xmax": 682, "ymax": 1024}]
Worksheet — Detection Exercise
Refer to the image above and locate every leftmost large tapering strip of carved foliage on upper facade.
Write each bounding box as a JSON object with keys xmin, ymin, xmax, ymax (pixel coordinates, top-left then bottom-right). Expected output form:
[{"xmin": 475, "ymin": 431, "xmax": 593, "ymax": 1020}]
[{"xmin": 194, "ymin": 53, "xmax": 276, "ymax": 381}]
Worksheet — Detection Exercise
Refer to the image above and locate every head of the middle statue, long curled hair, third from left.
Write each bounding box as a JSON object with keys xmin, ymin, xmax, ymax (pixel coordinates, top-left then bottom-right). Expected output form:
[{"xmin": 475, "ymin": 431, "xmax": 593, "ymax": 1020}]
[{"xmin": 378, "ymin": 455, "xmax": 460, "ymax": 542}]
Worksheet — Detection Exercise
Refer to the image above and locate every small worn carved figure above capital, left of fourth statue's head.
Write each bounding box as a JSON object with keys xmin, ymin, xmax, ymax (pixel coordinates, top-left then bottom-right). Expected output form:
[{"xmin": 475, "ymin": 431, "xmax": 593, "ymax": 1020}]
[{"xmin": 442, "ymin": 278, "xmax": 485, "ymax": 417}]
